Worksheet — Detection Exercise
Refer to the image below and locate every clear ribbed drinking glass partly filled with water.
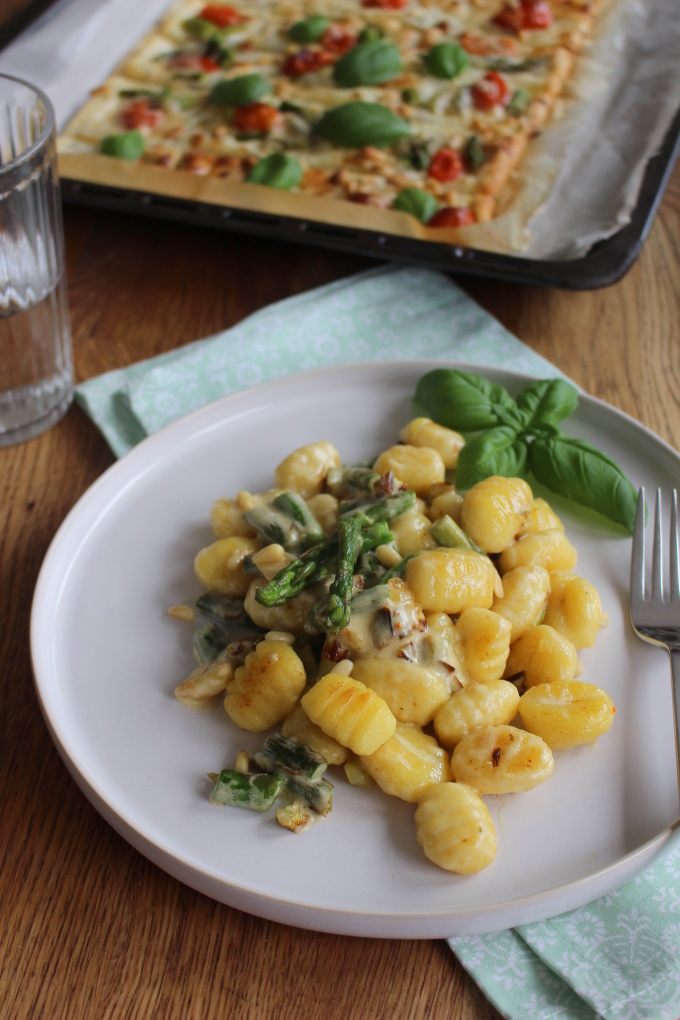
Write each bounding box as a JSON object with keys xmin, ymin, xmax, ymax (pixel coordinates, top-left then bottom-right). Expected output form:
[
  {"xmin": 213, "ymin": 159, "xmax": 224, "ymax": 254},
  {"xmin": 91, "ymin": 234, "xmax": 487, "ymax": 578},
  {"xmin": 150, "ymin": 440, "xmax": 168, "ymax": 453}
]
[{"xmin": 0, "ymin": 75, "xmax": 73, "ymax": 447}]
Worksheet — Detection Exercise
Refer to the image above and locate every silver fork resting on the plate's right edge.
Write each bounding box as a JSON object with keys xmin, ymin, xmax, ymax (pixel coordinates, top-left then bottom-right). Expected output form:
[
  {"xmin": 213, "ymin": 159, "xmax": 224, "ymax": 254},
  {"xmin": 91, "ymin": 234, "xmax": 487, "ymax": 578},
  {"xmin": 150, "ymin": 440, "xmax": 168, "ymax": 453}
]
[{"xmin": 630, "ymin": 488, "xmax": 680, "ymax": 783}]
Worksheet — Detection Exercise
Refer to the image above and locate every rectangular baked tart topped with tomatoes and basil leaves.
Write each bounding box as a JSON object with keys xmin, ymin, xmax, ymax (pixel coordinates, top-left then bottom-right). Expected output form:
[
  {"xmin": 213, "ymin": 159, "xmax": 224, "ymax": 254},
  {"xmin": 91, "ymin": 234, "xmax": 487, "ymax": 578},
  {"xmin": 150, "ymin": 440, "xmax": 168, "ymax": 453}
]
[{"xmin": 60, "ymin": 0, "xmax": 611, "ymax": 231}]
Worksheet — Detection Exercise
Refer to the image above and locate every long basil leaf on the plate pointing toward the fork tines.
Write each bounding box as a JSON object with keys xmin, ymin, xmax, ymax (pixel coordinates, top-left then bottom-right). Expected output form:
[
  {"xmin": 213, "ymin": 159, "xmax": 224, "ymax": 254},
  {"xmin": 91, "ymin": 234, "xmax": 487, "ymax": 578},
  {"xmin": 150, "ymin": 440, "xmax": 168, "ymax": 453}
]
[{"xmin": 526, "ymin": 436, "xmax": 637, "ymax": 534}]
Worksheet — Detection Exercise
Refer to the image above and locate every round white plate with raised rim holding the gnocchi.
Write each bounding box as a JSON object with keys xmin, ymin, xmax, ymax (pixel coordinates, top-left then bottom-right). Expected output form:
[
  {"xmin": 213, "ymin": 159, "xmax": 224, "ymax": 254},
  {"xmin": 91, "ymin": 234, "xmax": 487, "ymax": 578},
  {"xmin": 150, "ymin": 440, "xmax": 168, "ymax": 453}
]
[{"xmin": 32, "ymin": 362, "xmax": 680, "ymax": 937}]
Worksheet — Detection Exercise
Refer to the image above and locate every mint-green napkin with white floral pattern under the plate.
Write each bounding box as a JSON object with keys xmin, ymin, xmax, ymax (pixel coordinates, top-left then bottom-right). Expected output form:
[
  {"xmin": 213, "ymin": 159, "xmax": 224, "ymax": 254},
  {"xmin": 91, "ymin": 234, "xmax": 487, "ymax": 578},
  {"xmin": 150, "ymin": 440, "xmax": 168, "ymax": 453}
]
[{"xmin": 76, "ymin": 268, "xmax": 680, "ymax": 1020}]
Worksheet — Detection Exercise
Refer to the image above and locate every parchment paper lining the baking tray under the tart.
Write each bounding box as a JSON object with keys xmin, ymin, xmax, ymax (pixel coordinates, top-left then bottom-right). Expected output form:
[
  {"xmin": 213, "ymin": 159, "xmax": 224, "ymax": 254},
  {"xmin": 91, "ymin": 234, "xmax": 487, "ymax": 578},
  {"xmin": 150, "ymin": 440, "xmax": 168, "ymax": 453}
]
[{"xmin": 5, "ymin": 0, "xmax": 680, "ymax": 259}]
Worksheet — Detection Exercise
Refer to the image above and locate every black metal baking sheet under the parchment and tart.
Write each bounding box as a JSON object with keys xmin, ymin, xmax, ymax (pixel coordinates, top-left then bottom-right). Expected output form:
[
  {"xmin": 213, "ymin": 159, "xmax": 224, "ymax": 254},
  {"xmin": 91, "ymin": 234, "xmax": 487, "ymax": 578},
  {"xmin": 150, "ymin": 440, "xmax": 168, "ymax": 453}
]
[{"xmin": 61, "ymin": 103, "xmax": 680, "ymax": 291}]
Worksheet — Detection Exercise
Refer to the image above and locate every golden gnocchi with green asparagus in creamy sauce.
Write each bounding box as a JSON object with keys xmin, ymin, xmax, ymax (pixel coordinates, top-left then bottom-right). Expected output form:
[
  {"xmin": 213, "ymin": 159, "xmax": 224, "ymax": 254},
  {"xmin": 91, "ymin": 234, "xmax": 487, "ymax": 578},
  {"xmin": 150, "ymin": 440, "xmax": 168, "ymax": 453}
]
[{"xmin": 173, "ymin": 377, "xmax": 628, "ymax": 874}]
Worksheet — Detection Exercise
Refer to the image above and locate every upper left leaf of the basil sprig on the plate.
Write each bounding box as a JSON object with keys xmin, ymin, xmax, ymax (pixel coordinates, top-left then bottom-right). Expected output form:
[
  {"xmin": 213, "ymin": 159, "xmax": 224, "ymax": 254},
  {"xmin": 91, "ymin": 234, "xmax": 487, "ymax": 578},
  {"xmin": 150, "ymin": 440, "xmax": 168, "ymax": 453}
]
[{"xmin": 415, "ymin": 368, "xmax": 522, "ymax": 432}]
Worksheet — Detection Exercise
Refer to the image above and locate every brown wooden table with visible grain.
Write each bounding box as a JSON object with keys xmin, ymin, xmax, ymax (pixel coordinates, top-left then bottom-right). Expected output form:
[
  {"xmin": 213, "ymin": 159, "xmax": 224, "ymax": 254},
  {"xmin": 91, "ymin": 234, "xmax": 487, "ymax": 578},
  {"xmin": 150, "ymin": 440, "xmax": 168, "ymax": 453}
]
[{"xmin": 0, "ymin": 163, "xmax": 680, "ymax": 1020}]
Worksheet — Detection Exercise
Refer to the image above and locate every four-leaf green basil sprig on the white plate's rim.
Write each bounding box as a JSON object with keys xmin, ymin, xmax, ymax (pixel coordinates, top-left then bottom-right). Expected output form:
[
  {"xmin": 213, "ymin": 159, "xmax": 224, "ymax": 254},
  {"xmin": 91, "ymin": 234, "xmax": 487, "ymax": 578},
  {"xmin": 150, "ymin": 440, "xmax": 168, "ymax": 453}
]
[{"xmin": 415, "ymin": 368, "xmax": 637, "ymax": 533}]
